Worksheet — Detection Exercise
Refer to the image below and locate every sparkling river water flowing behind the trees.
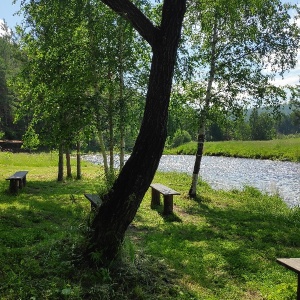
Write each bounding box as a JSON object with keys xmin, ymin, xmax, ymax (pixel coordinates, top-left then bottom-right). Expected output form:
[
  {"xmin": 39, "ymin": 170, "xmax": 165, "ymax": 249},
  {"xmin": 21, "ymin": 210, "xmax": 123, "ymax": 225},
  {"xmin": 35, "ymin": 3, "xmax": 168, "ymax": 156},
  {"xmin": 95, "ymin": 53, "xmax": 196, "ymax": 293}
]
[{"xmin": 83, "ymin": 155, "xmax": 300, "ymax": 207}]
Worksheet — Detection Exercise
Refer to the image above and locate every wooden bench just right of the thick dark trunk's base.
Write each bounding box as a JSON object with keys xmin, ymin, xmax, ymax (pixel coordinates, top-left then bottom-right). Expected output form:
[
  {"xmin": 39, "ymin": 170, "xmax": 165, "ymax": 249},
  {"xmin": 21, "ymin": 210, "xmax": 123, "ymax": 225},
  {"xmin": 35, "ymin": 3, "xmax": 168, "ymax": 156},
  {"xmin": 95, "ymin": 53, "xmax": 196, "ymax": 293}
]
[{"xmin": 150, "ymin": 183, "xmax": 180, "ymax": 215}]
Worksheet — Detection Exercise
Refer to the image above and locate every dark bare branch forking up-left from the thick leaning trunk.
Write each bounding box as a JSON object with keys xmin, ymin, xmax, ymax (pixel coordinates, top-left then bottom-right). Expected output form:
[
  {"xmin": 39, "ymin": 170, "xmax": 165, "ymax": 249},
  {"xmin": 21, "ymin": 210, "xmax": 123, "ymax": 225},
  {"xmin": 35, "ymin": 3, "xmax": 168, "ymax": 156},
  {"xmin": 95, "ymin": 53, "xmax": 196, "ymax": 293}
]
[{"xmin": 101, "ymin": 0, "xmax": 159, "ymax": 46}]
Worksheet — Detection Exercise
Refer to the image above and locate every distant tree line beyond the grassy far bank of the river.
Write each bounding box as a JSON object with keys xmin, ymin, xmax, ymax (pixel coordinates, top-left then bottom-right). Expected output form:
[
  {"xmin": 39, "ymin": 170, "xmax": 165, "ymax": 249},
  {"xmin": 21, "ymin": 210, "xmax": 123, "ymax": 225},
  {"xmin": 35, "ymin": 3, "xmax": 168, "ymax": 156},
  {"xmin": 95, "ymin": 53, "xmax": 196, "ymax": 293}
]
[{"xmin": 167, "ymin": 105, "xmax": 300, "ymax": 147}]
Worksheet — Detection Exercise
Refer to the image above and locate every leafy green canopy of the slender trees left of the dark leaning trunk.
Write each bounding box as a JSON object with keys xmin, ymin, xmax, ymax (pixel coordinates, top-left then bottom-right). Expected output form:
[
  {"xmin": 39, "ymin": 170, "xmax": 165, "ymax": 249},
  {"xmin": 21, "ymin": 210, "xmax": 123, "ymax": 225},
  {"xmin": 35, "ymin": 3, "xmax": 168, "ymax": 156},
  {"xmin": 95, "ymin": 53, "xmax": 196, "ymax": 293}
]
[{"xmin": 15, "ymin": 0, "xmax": 149, "ymax": 155}]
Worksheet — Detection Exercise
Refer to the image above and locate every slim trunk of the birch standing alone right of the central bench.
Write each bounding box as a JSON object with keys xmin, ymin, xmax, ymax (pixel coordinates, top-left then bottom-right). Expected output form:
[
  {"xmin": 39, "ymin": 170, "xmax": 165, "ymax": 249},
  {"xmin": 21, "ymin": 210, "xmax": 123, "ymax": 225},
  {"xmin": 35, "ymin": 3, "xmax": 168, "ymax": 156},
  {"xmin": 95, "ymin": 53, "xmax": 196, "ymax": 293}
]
[{"xmin": 189, "ymin": 16, "xmax": 218, "ymax": 198}]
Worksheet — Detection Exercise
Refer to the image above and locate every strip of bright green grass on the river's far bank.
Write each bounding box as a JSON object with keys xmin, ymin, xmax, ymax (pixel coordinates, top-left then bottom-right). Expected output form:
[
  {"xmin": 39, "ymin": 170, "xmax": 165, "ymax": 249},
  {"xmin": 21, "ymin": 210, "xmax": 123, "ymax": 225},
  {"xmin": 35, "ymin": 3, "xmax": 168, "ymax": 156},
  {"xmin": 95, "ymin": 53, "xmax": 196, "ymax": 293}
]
[{"xmin": 165, "ymin": 138, "xmax": 300, "ymax": 162}]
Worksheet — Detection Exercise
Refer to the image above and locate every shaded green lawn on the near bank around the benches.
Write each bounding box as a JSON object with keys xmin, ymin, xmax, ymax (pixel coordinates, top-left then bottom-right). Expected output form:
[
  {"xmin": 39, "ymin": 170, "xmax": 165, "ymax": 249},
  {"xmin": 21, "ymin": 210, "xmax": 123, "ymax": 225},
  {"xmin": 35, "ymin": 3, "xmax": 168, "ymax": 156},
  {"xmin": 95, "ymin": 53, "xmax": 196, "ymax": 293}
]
[{"xmin": 0, "ymin": 152, "xmax": 300, "ymax": 300}]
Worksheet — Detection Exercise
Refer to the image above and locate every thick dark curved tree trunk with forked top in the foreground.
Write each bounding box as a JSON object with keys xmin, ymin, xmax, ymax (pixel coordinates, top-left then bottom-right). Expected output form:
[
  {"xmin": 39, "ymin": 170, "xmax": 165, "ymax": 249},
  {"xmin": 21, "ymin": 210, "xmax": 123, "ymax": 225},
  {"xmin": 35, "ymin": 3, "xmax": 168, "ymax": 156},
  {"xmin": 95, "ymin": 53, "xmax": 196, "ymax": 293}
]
[{"xmin": 87, "ymin": 0, "xmax": 186, "ymax": 262}]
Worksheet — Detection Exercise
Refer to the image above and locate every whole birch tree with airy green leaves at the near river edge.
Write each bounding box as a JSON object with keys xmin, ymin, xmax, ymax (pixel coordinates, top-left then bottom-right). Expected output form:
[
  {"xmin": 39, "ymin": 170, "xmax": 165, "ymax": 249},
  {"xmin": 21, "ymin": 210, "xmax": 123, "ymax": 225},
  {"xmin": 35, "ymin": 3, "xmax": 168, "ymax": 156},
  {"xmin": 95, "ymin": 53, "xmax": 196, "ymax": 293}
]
[{"xmin": 187, "ymin": 0, "xmax": 299, "ymax": 197}]
